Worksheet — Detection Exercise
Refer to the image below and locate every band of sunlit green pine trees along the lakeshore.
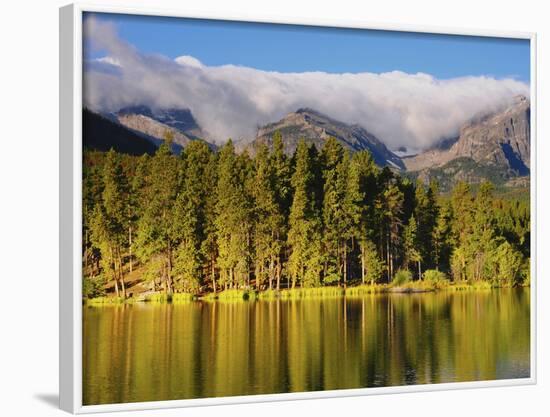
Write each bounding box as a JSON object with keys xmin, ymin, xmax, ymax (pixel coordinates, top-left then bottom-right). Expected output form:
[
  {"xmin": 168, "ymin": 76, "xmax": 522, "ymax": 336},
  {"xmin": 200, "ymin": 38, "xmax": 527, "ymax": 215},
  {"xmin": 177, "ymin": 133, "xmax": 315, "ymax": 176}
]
[{"xmin": 82, "ymin": 132, "xmax": 530, "ymax": 297}]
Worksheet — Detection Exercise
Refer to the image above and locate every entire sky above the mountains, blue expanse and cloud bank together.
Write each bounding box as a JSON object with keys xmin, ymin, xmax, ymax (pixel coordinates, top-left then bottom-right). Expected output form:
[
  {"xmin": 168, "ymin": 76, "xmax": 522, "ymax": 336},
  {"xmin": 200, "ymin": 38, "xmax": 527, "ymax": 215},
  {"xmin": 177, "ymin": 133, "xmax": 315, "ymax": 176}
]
[{"xmin": 84, "ymin": 14, "xmax": 530, "ymax": 149}]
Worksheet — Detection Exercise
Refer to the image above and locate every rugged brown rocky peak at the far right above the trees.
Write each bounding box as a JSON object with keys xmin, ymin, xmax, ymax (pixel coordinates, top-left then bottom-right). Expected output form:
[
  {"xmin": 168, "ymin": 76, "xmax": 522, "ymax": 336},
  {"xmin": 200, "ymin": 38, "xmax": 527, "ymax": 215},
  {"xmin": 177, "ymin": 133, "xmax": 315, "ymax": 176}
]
[{"xmin": 403, "ymin": 96, "xmax": 531, "ymax": 181}]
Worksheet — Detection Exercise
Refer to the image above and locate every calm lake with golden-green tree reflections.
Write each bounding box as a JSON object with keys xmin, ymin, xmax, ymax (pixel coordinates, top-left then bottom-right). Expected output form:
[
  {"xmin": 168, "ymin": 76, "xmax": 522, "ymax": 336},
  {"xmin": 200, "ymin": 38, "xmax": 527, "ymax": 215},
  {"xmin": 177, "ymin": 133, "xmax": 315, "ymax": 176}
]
[{"xmin": 83, "ymin": 290, "xmax": 530, "ymax": 405}]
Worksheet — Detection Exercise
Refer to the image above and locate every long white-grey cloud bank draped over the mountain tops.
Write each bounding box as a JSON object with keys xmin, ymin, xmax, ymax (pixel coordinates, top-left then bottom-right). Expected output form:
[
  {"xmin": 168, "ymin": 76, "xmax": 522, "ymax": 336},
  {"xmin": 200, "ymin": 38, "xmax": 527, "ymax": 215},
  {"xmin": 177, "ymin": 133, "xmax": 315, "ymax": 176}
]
[{"xmin": 84, "ymin": 17, "xmax": 529, "ymax": 149}]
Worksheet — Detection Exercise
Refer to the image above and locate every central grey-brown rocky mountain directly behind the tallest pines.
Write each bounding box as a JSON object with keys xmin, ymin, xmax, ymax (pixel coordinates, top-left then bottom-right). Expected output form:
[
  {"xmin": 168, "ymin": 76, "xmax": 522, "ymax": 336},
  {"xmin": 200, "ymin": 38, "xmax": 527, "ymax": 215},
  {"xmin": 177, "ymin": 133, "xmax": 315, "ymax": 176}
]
[{"xmin": 244, "ymin": 108, "xmax": 405, "ymax": 169}]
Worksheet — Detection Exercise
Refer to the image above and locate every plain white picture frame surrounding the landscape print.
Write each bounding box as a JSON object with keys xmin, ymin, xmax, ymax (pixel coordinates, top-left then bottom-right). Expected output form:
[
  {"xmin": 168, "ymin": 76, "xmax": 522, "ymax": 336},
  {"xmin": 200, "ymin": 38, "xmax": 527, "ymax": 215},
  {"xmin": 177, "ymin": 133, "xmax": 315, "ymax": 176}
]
[{"xmin": 59, "ymin": 3, "xmax": 537, "ymax": 414}]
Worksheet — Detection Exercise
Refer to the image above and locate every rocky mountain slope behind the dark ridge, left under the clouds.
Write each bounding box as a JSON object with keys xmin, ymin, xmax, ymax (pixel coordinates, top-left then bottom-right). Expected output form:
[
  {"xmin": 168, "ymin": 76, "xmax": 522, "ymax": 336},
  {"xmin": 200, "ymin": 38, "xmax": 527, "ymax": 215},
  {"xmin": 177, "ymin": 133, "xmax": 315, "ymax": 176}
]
[{"xmin": 113, "ymin": 106, "xmax": 215, "ymax": 149}]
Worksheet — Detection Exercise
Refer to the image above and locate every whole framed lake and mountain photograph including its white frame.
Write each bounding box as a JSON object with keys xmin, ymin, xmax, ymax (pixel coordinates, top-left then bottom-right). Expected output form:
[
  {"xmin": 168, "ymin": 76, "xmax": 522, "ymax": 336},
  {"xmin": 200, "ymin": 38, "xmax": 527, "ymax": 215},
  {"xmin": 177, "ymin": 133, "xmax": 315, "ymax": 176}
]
[{"xmin": 60, "ymin": 5, "xmax": 536, "ymax": 413}]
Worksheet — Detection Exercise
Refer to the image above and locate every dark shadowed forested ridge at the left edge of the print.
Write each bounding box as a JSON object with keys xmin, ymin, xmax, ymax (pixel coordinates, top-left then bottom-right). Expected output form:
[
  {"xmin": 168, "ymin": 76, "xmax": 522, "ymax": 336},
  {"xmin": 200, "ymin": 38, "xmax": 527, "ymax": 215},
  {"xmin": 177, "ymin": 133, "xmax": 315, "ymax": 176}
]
[{"xmin": 82, "ymin": 109, "xmax": 157, "ymax": 155}]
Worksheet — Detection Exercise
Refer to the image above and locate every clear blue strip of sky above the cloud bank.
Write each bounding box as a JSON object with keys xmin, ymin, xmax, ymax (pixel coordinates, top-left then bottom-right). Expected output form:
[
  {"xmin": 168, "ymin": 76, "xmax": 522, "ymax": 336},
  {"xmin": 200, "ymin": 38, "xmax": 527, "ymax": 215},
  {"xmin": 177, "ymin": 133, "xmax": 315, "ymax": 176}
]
[{"xmin": 84, "ymin": 14, "xmax": 530, "ymax": 82}]
